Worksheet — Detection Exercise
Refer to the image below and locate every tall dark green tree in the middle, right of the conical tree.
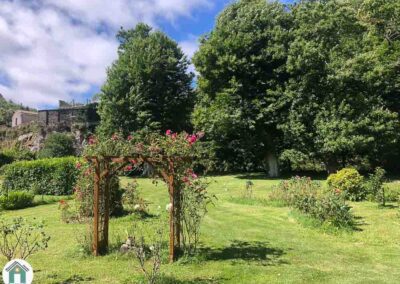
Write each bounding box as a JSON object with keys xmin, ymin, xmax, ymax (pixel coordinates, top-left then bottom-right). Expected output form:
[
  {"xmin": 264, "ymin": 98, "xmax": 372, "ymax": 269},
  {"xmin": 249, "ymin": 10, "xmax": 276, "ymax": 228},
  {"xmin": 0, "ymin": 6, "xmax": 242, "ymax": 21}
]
[{"xmin": 193, "ymin": 0, "xmax": 291, "ymax": 170}]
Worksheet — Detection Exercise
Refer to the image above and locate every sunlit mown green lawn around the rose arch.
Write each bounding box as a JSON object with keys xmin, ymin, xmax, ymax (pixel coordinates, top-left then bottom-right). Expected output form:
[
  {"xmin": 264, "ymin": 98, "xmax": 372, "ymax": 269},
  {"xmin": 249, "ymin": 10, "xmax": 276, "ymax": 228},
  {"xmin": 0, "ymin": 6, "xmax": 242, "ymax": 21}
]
[{"xmin": 0, "ymin": 176, "xmax": 400, "ymax": 283}]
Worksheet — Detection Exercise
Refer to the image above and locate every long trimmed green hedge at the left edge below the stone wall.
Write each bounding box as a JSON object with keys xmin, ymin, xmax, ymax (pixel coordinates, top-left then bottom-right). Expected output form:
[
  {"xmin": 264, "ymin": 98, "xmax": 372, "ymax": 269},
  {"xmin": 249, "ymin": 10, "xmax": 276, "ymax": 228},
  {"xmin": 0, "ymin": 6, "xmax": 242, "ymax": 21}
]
[{"xmin": 1, "ymin": 157, "xmax": 79, "ymax": 195}]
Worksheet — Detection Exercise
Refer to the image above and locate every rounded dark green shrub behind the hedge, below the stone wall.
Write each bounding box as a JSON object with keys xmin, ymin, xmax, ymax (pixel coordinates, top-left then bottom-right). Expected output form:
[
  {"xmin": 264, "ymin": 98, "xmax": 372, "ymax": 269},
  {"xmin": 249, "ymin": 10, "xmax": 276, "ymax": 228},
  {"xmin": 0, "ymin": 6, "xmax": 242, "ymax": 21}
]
[{"xmin": 39, "ymin": 133, "xmax": 75, "ymax": 159}]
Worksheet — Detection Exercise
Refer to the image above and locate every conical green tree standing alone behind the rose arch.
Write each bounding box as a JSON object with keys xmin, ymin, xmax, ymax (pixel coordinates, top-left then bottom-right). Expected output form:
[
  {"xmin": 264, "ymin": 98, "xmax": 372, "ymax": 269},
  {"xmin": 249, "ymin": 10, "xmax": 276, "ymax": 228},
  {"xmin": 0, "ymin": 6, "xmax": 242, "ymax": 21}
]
[{"xmin": 99, "ymin": 24, "xmax": 194, "ymax": 135}]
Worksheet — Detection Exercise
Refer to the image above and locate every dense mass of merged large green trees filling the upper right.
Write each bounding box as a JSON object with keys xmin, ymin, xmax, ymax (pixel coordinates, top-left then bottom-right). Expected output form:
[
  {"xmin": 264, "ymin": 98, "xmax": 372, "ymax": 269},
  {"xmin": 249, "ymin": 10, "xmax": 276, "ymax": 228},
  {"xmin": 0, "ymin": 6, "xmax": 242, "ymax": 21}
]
[{"xmin": 193, "ymin": 0, "xmax": 400, "ymax": 173}]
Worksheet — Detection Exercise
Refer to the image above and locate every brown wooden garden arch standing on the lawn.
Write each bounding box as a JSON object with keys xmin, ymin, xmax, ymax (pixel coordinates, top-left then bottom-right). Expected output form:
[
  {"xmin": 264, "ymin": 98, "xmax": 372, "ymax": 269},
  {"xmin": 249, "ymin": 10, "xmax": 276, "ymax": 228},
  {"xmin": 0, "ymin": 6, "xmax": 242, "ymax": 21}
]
[{"xmin": 86, "ymin": 154, "xmax": 188, "ymax": 262}]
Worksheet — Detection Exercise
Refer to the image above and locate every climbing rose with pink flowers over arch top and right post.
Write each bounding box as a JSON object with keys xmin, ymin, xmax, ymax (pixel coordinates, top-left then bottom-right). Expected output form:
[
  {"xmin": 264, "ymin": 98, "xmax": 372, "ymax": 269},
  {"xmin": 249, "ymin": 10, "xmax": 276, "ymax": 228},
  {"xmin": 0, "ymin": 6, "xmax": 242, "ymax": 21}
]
[{"xmin": 79, "ymin": 130, "xmax": 210, "ymax": 258}]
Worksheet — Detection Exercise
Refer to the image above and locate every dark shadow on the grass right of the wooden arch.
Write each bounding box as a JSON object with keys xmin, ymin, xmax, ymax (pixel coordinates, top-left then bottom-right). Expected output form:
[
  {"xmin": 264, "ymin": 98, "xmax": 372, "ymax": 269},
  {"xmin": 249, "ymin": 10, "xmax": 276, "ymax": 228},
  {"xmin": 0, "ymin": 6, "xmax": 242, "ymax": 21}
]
[{"xmin": 199, "ymin": 240, "xmax": 287, "ymax": 265}]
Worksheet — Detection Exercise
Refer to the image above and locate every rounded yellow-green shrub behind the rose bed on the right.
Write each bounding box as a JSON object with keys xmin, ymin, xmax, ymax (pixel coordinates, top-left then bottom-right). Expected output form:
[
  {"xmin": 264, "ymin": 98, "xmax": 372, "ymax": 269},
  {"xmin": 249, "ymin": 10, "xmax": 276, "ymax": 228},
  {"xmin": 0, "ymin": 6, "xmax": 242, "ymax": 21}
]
[{"xmin": 327, "ymin": 168, "xmax": 367, "ymax": 201}]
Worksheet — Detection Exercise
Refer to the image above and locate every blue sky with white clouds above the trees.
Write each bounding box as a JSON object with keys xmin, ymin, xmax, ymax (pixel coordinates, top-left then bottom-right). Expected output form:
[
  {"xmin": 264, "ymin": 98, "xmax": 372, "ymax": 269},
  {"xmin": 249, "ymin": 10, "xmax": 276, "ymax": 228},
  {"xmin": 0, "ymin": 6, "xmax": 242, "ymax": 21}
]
[{"xmin": 0, "ymin": 0, "xmax": 294, "ymax": 109}]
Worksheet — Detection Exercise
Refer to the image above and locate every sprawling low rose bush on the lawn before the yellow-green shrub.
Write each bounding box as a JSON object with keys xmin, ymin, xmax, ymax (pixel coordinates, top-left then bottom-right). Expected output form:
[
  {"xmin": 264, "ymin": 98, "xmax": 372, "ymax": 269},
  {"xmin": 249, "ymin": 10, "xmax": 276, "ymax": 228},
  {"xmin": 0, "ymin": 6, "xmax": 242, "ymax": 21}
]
[{"xmin": 269, "ymin": 177, "xmax": 354, "ymax": 227}]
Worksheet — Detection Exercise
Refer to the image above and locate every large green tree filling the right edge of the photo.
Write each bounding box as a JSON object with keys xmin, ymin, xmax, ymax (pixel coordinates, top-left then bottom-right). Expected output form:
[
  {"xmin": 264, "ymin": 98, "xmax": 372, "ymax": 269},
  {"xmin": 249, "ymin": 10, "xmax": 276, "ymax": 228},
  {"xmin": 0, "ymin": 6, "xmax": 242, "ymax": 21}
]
[{"xmin": 278, "ymin": 0, "xmax": 400, "ymax": 172}]
